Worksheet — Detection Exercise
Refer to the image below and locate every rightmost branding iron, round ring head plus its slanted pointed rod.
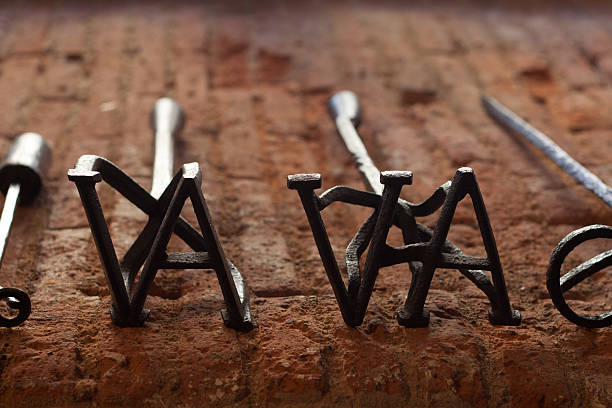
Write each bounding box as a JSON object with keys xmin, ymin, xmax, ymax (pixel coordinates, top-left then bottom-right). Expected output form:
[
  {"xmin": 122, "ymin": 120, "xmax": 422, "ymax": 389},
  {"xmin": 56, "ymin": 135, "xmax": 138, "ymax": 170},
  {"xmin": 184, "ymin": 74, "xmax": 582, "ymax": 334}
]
[{"xmin": 482, "ymin": 96, "xmax": 612, "ymax": 328}]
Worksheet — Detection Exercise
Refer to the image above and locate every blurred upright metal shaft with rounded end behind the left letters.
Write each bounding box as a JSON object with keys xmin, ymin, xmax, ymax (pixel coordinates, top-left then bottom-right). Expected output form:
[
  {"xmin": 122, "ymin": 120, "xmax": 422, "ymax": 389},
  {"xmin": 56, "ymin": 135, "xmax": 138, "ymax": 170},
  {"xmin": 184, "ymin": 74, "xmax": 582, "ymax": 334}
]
[{"xmin": 151, "ymin": 98, "xmax": 185, "ymax": 198}]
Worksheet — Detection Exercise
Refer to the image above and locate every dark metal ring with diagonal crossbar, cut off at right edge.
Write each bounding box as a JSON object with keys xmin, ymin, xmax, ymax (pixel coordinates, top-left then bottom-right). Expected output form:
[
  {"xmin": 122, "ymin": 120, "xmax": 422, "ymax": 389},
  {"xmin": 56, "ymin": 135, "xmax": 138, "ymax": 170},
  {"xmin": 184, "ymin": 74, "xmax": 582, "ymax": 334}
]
[{"xmin": 546, "ymin": 225, "xmax": 612, "ymax": 328}]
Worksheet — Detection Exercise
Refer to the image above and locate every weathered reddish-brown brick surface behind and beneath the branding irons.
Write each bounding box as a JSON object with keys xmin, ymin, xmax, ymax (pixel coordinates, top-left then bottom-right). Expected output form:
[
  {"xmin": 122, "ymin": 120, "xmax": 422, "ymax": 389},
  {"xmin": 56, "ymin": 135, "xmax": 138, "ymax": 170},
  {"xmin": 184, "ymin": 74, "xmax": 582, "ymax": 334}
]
[{"xmin": 0, "ymin": 1, "xmax": 612, "ymax": 408}]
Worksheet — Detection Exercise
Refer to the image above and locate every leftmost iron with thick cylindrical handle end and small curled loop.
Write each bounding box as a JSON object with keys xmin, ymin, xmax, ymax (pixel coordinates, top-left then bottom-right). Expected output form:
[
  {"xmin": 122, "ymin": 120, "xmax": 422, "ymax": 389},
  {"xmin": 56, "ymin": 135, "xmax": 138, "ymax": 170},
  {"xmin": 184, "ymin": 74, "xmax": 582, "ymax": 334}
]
[{"xmin": 0, "ymin": 133, "xmax": 51, "ymax": 327}]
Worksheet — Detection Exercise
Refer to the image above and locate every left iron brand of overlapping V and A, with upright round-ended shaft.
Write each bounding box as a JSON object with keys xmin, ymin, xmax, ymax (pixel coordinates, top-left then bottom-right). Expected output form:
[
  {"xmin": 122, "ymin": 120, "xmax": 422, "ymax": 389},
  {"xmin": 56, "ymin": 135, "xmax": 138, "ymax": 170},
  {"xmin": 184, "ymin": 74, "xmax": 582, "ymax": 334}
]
[{"xmin": 68, "ymin": 98, "xmax": 253, "ymax": 331}]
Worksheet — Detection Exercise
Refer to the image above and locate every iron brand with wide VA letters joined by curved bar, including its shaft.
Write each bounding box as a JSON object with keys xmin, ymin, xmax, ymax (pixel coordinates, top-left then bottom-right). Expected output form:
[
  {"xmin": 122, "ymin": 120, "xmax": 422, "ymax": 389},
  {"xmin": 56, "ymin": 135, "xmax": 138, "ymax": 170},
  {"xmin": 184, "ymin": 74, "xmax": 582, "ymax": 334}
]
[{"xmin": 287, "ymin": 91, "xmax": 521, "ymax": 327}]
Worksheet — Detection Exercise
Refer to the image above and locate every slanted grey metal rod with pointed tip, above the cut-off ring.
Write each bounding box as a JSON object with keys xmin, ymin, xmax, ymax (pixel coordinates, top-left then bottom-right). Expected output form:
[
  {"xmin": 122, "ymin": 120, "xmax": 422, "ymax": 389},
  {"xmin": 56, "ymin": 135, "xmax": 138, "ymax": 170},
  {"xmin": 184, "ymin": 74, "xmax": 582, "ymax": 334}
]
[{"xmin": 482, "ymin": 96, "xmax": 612, "ymax": 207}]
